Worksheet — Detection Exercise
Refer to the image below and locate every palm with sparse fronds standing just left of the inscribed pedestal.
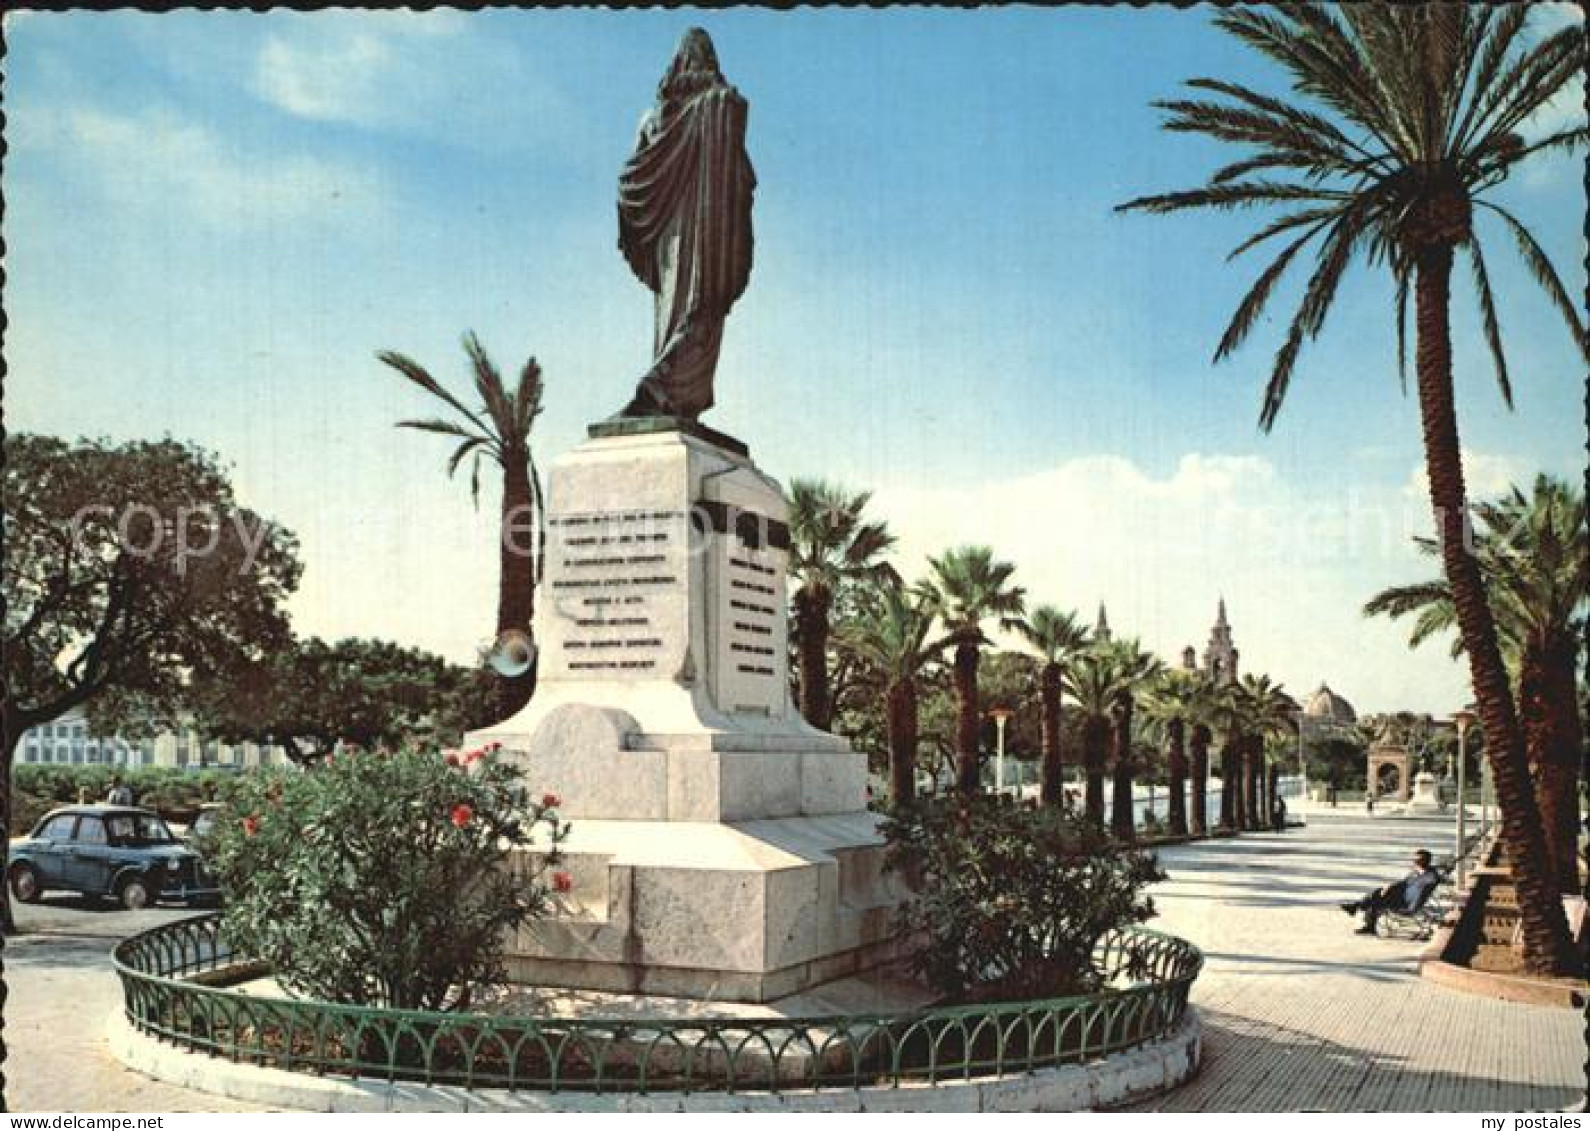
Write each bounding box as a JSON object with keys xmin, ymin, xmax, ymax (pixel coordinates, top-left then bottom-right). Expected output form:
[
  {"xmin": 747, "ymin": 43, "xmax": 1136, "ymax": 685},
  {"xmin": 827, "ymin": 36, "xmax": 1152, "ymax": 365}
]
[{"xmin": 375, "ymin": 331, "xmax": 545, "ymax": 714}]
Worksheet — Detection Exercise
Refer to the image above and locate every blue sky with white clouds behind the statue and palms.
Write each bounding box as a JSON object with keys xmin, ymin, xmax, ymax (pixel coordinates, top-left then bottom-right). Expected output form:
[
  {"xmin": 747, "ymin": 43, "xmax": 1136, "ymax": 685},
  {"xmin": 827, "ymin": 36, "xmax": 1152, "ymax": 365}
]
[{"xmin": 3, "ymin": 6, "xmax": 1585, "ymax": 711}]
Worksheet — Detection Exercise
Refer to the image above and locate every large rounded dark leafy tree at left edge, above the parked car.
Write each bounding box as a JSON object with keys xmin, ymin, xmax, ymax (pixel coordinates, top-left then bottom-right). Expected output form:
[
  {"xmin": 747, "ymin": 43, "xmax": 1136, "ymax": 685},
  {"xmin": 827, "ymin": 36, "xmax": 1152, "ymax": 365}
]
[{"xmin": 0, "ymin": 434, "xmax": 301, "ymax": 929}]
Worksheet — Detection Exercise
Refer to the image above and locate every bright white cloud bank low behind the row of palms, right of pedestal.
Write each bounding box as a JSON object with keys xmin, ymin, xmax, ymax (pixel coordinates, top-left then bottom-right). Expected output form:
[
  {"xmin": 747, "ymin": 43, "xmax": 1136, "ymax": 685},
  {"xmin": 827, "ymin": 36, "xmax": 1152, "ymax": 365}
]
[{"xmin": 873, "ymin": 453, "xmax": 1523, "ymax": 709}]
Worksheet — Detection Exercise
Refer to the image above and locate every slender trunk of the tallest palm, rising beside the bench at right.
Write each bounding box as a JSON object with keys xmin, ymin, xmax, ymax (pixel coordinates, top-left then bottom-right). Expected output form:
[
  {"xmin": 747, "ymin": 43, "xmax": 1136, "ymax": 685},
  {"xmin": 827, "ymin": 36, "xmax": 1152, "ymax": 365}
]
[{"xmin": 1414, "ymin": 245, "xmax": 1574, "ymax": 974}]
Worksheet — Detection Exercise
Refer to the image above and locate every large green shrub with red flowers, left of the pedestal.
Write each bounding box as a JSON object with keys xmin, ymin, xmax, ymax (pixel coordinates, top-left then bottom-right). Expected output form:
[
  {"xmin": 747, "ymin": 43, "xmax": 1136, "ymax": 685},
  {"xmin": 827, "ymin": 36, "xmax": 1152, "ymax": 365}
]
[{"xmin": 211, "ymin": 748, "xmax": 574, "ymax": 1009}]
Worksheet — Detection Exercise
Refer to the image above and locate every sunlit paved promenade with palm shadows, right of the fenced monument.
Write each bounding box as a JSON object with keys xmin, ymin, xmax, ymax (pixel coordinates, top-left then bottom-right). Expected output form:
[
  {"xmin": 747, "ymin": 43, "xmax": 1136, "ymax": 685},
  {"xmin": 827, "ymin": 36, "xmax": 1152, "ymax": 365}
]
[{"xmin": 1143, "ymin": 810, "xmax": 1585, "ymax": 1112}]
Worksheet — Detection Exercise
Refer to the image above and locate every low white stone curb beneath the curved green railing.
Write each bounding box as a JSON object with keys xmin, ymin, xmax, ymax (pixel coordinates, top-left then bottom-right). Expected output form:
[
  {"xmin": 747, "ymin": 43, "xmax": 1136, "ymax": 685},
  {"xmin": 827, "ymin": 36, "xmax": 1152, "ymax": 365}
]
[{"xmin": 107, "ymin": 1007, "xmax": 1202, "ymax": 1112}]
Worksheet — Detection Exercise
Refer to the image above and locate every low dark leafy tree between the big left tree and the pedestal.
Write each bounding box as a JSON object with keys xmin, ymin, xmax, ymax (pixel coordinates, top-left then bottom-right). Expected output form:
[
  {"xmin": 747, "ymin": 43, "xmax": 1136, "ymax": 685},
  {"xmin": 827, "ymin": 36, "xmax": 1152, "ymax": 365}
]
[{"xmin": 199, "ymin": 638, "xmax": 494, "ymax": 764}]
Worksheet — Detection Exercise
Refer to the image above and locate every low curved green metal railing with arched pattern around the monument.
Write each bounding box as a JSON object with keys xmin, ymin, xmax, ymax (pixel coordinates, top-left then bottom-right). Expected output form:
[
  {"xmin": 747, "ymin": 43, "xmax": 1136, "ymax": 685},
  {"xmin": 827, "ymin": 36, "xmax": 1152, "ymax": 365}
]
[{"xmin": 114, "ymin": 915, "xmax": 1204, "ymax": 1091}]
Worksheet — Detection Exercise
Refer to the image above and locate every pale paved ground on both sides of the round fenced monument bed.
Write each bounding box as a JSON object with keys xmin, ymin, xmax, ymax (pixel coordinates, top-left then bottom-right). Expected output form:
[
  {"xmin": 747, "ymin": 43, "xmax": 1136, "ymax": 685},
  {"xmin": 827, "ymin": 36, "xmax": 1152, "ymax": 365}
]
[{"xmin": 5, "ymin": 813, "xmax": 1585, "ymax": 1112}]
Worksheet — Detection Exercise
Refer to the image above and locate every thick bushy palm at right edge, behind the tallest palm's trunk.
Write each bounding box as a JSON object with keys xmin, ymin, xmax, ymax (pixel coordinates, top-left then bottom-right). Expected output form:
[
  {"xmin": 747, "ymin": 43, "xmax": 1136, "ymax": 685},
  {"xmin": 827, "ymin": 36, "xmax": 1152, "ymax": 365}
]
[{"xmin": 1364, "ymin": 476, "xmax": 1590, "ymax": 894}]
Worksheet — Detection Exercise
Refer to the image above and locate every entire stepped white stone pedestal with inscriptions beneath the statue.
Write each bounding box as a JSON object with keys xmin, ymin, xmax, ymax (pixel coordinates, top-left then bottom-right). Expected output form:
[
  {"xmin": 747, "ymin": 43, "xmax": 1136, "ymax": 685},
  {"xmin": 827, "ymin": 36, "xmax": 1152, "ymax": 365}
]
[{"xmin": 471, "ymin": 422, "xmax": 900, "ymax": 1001}]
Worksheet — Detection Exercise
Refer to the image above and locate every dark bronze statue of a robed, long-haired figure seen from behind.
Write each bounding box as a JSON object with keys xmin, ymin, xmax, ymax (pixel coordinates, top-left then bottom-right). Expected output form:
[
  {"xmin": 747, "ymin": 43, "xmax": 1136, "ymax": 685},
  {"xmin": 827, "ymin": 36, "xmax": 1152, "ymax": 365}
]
[{"xmin": 619, "ymin": 30, "xmax": 757, "ymax": 420}]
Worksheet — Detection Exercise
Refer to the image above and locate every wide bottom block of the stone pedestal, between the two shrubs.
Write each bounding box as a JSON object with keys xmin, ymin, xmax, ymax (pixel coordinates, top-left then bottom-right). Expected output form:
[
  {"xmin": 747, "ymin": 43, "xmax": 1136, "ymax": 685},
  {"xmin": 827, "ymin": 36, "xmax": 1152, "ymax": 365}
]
[{"xmin": 507, "ymin": 813, "xmax": 905, "ymax": 1002}]
